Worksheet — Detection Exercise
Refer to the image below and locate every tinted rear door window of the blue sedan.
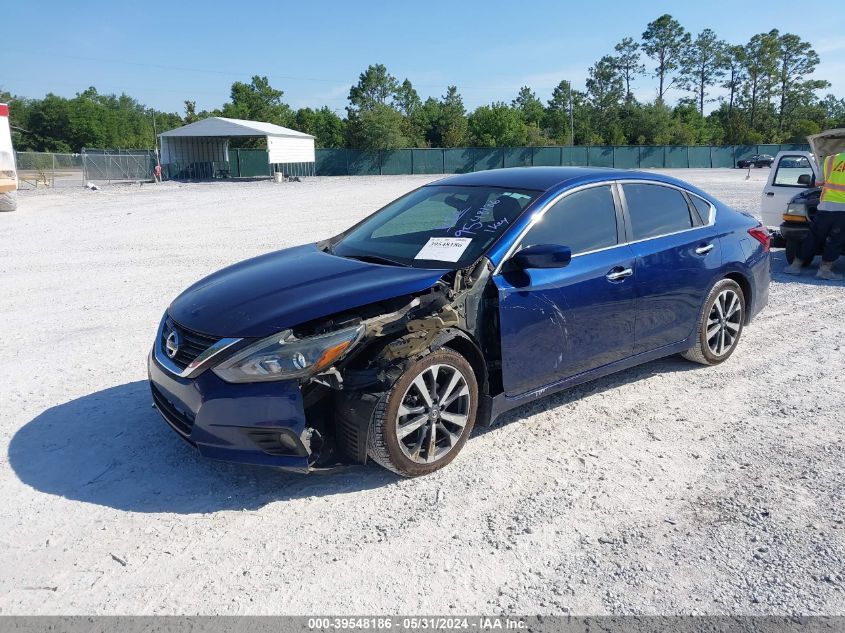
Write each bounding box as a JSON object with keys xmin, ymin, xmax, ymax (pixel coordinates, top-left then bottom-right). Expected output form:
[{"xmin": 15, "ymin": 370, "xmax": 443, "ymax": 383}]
[{"xmin": 622, "ymin": 184, "xmax": 693, "ymax": 240}]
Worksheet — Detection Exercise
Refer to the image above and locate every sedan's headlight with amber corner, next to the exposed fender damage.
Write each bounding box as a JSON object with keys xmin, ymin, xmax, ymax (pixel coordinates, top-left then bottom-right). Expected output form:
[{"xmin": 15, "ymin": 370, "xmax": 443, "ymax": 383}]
[{"xmin": 214, "ymin": 325, "xmax": 364, "ymax": 382}]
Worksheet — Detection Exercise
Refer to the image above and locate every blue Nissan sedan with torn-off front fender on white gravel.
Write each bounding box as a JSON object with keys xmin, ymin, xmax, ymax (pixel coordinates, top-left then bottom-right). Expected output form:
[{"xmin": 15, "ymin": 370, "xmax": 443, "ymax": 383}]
[{"xmin": 148, "ymin": 167, "xmax": 770, "ymax": 476}]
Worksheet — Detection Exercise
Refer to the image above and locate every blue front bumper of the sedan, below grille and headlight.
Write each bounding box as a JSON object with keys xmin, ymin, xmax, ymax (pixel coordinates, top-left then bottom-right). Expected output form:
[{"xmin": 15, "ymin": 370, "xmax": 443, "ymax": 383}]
[{"xmin": 147, "ymin": 353, "xmax": 313, "ymax": 472}]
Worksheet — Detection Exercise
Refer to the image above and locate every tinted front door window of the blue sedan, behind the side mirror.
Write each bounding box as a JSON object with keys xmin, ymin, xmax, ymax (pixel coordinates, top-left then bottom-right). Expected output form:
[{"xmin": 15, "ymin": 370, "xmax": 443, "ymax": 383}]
[{"xmin": 522, "ymin": 185, "xmax": 618, "ymax": 255}]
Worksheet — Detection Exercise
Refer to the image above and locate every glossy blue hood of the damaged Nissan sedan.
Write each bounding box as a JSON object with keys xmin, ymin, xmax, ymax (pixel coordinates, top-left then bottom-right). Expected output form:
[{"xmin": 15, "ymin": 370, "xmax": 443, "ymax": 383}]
[{"xmin": 167, "ymin": 244, "xmax": 448, "ymax": 338}]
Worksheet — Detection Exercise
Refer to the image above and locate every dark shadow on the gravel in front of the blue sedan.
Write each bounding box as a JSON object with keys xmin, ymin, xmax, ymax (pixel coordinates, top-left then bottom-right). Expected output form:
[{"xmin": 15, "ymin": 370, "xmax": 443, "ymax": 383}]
[{"xmin": 8, "ymin": 381, "xmax": 398, "ymax": 514}]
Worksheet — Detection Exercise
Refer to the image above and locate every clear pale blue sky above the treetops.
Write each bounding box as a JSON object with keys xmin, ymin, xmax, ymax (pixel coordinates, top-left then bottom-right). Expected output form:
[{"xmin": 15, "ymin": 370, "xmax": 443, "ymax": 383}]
[{"xmin": 0, "ymin": 0, "xmax": 845, "ymax": 115}]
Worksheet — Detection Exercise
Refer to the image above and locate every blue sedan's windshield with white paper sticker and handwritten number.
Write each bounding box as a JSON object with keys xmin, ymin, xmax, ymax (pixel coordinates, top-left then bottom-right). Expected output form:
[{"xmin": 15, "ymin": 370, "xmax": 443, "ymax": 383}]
[{"xmin": 332, "ymin": 185, "xmax": 540, "ymax": 268}]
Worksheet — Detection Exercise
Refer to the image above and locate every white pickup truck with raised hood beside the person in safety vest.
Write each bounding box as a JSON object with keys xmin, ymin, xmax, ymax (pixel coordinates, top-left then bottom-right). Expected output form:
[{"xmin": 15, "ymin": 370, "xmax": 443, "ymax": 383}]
[{"xmin": 760, "ymin": 128, "xmax": 845, "ymax": 265}]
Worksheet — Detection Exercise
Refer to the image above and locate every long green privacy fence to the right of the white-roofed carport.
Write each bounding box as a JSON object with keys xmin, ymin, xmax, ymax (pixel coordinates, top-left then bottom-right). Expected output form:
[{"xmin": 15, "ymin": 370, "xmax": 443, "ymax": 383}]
[{"xmin": 316, "ymin": 144, "xmax": 809, "ymax": 176}]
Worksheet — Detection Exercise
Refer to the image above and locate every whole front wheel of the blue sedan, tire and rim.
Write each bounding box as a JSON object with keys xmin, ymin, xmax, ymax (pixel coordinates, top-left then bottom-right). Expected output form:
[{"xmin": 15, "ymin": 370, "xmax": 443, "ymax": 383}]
[{"xmin": 367, "ymin": 349, "xmax": 478, "ymax": 477}]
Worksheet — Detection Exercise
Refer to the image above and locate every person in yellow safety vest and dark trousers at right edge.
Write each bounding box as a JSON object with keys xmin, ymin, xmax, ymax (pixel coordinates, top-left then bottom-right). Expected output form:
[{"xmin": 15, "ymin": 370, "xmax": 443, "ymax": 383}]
[{"xmin": 783, "ymin": 152, "xmax": 845, "ymax": 281}]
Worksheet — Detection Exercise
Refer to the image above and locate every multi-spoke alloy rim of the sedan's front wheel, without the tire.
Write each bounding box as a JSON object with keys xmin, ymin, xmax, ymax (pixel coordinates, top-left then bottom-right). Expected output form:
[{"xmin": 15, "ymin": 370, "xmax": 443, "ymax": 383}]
[{"xmin": 396, "ymin": 365, "xmax": 471, "ymax": 464}]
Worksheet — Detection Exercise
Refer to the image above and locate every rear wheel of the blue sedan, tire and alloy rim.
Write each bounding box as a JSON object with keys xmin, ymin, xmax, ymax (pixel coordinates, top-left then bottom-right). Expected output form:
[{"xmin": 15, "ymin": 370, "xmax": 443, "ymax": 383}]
[{"xmin": 681, "ymin": 279, "xmax": 745, "ymax": 365}]
